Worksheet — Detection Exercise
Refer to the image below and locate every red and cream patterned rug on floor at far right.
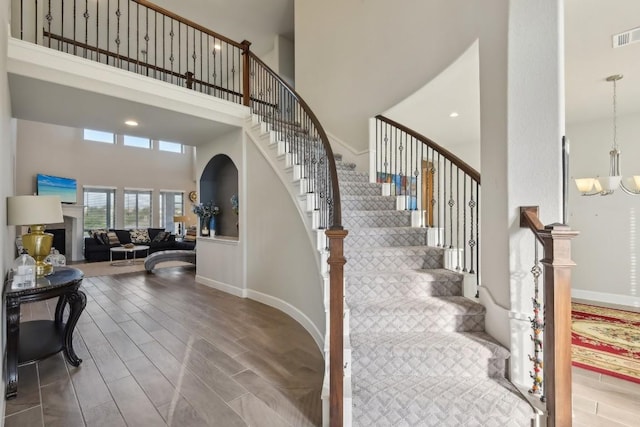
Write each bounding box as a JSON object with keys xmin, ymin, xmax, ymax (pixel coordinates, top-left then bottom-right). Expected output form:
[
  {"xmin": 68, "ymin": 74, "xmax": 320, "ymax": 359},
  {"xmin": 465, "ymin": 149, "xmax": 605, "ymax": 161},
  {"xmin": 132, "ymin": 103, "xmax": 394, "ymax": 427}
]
[{"xmin": 571, "ymin": 303, "xmax": 640, "ymax": 383}]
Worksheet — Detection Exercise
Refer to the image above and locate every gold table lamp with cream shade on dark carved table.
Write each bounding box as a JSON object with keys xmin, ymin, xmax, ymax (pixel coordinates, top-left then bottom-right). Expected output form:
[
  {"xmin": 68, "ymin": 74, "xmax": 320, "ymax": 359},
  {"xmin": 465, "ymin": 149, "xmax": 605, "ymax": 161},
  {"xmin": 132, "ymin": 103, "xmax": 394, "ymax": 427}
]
[{"xmin": 7, "ymin": 196, "xmax": 64, "ymax": 277}]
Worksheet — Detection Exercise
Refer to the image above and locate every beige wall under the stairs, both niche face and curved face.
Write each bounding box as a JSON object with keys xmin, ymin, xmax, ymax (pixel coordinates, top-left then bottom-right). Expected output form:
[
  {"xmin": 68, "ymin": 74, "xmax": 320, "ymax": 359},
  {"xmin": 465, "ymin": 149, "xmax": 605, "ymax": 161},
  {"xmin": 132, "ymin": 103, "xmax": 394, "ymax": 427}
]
[{"xmin": 197, "ymin": 126, "xmax": 325, "ymax": 347}]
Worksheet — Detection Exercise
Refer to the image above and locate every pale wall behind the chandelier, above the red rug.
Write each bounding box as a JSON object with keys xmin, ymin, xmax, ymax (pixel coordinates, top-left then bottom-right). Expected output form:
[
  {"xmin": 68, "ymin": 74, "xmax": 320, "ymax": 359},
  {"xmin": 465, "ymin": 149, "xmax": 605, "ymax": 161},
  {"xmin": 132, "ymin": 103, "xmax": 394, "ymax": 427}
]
[{"xmin": 567, "ymin": 114, "xmax": 640, "ymax": 307}]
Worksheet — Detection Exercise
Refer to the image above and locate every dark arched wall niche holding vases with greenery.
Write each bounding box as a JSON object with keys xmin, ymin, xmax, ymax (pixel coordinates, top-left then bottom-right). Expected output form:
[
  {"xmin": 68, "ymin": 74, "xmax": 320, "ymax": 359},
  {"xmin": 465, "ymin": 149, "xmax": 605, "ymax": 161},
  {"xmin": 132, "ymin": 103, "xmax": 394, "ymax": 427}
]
[{"xmin": 200, "ymin": 154, "xmax": 238, "ymax": 237}]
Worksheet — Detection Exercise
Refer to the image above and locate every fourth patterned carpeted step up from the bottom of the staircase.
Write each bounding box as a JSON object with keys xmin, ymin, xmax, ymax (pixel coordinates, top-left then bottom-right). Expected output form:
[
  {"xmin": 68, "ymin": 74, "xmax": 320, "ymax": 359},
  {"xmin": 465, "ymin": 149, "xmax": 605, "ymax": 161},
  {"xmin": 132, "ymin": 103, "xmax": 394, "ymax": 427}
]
[{"xmin": 345, "ymin": 268, "xmax": 463, "ymax": 304}]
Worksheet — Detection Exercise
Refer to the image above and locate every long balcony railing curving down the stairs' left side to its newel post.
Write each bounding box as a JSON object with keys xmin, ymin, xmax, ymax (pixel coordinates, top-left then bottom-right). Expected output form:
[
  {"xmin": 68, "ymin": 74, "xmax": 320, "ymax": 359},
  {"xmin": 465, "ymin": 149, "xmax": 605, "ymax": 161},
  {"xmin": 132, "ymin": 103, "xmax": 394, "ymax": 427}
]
[{"xmin": 11, "ymin": 0, "xmax": 347, "ymax": 426}]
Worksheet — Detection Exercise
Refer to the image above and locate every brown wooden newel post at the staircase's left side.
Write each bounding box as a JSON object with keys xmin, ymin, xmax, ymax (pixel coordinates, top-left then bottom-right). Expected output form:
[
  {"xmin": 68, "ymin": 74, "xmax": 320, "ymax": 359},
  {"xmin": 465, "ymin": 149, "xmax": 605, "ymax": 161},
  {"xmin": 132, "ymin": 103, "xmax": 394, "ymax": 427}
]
[{"xmin": 325, "ymin": 229, "xmax": 348, "ymax": 427}]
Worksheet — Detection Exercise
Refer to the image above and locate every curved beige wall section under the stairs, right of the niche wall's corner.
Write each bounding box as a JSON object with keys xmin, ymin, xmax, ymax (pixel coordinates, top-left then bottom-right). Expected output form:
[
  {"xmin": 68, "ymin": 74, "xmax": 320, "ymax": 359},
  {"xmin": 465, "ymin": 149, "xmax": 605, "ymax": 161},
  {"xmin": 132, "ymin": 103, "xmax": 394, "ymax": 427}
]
[{"xmin": 245, "ymin": 135, "xmax": 325, "ymax": 345}]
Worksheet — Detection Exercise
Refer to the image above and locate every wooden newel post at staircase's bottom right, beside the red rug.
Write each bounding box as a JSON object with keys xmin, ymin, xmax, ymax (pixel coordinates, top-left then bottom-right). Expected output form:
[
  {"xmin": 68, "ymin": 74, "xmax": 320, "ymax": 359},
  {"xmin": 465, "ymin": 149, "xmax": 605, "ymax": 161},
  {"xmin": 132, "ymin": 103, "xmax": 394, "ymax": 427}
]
[{"xmin": 538, "ymin": 224, "xmax": 578, "ymax": 427}]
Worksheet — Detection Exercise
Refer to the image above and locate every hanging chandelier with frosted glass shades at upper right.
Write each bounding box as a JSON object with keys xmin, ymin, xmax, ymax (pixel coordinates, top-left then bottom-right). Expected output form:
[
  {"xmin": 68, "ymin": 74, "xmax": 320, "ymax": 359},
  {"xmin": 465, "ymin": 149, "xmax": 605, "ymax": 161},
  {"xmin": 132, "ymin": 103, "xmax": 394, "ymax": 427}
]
[{"xmin": 575, "ymin": 74, "xmax": 640, "ymax": 196}]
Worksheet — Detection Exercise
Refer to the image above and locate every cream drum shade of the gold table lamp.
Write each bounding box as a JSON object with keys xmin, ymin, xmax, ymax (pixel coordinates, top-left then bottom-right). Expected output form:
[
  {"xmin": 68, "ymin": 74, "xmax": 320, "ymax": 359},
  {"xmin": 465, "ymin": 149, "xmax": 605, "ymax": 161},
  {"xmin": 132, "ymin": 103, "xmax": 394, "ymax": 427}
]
[{"xmin": 7, "ymin": 196, "xmax": 64, "ymax": 225}]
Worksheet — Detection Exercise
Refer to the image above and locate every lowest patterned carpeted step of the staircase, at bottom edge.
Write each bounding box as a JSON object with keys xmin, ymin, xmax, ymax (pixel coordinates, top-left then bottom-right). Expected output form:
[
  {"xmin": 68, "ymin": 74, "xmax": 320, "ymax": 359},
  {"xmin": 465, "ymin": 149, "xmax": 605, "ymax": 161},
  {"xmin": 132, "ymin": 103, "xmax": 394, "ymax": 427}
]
[{"xmin": 353, "ymin": 375, "xmax": 533, "ymax": 427}]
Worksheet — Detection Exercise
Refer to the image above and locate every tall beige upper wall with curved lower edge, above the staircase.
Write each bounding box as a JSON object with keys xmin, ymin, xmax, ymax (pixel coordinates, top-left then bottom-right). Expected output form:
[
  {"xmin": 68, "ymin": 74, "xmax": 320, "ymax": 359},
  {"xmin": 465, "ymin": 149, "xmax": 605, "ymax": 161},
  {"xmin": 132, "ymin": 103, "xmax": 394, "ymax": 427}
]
[{"xmin": 295, "ymin": 0, "xmax": 496, "ymax": 151}]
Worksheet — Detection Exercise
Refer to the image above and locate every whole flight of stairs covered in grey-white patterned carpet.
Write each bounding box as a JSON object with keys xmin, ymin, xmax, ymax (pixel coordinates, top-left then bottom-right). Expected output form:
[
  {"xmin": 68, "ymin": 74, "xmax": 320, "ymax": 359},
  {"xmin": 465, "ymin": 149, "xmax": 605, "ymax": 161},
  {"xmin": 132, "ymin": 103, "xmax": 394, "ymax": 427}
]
[{"xmin": 337, "ymin": 161, "xmax": 534, "ymax": 427}]
